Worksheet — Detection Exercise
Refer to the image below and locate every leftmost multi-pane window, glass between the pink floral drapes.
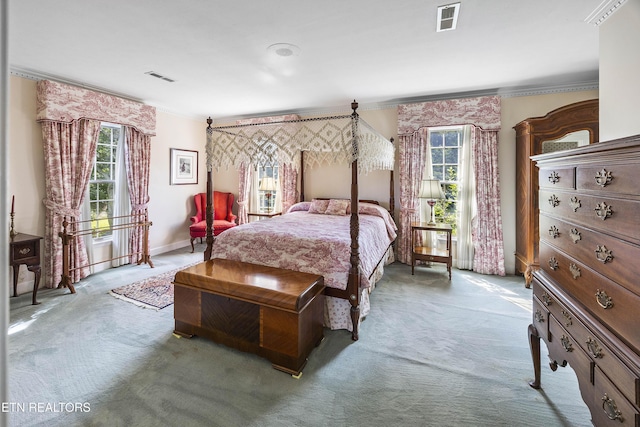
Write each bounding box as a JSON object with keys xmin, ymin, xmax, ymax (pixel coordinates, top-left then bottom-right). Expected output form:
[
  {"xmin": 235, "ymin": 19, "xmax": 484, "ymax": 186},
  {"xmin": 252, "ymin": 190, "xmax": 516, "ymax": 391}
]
[{"xmin": 89, "ymin": 123, "xmax": 122, "ymax": 238}]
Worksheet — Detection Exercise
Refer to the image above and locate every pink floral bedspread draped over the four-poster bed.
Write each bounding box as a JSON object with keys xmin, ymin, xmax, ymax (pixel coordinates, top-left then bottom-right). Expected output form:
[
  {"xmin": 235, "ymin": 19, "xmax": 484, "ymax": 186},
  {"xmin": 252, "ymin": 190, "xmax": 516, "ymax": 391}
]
[{"xmin": 212, "ymin": 203, "xmax": 396, "ymax": 289}]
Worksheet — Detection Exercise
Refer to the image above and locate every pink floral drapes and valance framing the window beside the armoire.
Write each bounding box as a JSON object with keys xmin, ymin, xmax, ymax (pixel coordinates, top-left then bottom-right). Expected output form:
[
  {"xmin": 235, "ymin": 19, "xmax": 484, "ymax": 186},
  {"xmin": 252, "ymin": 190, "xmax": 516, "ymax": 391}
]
[{"xmin": 398, "ymin": 96, "xmax": 504, "ymax": 275}]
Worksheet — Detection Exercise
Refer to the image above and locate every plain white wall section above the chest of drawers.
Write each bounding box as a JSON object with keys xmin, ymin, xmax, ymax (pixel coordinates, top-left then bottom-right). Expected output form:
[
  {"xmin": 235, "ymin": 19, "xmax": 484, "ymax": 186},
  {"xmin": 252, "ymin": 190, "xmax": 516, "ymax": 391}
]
[{"xmin": 599, "ymin": 0, "xmax": 640, "ymax": 141}]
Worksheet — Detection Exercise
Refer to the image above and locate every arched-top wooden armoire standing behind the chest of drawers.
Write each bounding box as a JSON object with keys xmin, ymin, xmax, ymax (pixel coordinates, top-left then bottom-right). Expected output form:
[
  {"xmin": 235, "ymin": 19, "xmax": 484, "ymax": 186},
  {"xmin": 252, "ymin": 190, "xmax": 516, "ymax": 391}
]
[{"xmin": 514, "ymin": 99, "xmax": 599, "ymax": 287}]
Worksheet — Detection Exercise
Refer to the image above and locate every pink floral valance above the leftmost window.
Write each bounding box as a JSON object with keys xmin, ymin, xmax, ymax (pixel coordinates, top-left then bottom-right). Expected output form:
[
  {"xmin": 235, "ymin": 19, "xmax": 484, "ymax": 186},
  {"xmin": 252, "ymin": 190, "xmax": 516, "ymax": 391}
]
[{"xmin": 36, "ymin": 80, "xmax": 156, "ymax": 136}]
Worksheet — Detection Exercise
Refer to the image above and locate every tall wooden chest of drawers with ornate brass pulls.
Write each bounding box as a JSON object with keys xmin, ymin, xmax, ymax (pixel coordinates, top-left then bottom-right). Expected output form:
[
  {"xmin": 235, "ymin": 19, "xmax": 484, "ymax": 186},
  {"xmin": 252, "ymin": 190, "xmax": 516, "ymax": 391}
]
[{"xmin": 529, "ymin": 135, "xmax": 640, "ymax": 426}]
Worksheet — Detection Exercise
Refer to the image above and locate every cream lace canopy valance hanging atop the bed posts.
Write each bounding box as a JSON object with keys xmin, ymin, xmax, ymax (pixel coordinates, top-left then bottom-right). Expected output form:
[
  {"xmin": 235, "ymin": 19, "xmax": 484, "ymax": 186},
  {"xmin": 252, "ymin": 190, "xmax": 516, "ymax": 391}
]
[{"xmin": 206, "ymin": 104, "xmax": 394, "ymax": 173}]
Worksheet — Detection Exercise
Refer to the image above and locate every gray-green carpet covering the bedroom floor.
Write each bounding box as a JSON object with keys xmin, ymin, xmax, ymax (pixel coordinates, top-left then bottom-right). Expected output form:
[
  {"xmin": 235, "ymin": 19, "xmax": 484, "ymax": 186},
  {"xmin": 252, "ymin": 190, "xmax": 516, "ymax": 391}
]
[{"xmin": 8, "ymin": 246, "xmax": 591, "ymax": 427}]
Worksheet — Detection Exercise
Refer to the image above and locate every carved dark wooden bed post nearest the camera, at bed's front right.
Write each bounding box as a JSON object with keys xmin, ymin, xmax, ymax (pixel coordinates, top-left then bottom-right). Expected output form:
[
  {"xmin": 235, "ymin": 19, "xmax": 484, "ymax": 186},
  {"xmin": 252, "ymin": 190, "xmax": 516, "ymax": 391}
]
[{"xmin": 347, "ymin": 99, "xmax": 360, "ymax": 341}]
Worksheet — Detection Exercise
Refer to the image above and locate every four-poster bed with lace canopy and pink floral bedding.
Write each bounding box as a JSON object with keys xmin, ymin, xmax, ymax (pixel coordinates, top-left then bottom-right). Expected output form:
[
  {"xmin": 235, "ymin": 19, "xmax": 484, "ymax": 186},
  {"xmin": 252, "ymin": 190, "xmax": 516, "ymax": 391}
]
[{"xmin": 204, "ymin": 101, "xmax": 396, "ymax": 340}]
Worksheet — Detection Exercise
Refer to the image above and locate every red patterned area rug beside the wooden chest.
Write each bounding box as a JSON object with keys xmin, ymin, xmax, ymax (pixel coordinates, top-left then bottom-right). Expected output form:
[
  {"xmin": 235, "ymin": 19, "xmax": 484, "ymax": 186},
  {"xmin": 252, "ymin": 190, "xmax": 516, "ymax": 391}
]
[{"xmin": 109, "ymin": 262, "xmax": 198, "ymax": 310}]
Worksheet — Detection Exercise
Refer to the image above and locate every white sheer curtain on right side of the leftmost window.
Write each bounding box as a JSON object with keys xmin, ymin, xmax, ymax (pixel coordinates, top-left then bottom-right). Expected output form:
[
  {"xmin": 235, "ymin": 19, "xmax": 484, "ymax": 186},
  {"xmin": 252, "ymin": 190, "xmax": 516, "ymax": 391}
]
[{"xmin": 111, "ymin": 130, "xmax": 131, "ymax": 267}]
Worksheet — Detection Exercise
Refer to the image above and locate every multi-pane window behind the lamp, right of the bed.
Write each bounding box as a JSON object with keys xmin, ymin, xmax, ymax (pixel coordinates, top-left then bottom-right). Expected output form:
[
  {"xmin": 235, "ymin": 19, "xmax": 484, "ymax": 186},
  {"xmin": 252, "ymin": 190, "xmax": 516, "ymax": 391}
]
[{"xmin": 429, "ymin": 126, "xmax": 463, "ymax": 236}]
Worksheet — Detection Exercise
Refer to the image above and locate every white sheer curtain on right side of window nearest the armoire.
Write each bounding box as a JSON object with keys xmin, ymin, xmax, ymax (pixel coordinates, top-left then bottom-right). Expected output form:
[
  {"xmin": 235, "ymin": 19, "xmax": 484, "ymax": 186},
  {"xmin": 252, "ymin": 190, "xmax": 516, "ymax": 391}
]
[{"xmin": 454, "ymin": 125, "xmax": 477, "ymax": 270}]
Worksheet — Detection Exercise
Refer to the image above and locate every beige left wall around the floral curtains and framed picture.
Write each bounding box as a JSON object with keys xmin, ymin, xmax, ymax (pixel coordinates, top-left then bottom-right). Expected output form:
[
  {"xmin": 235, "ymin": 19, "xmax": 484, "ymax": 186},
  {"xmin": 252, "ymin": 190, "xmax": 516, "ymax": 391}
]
[{"xmin": 8, "ymin": 76, "xmax": 208, "ymax": 292}]
